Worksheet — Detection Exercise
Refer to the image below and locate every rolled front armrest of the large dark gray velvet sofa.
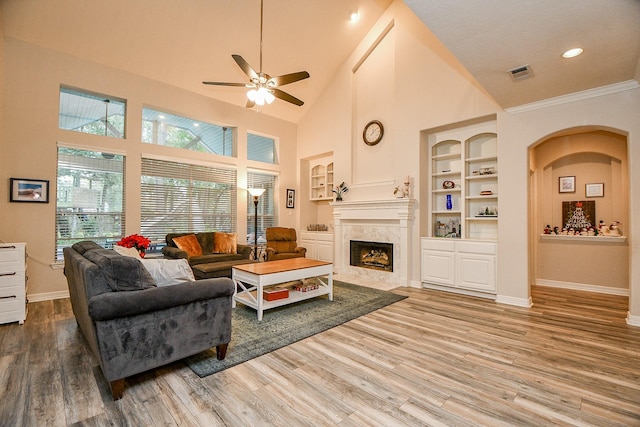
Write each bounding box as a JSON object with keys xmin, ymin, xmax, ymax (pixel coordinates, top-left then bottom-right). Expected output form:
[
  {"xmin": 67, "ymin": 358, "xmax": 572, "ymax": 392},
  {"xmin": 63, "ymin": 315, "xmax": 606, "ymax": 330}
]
[{"xmin": 89, "ymin": 277, "xmax": 235, "ymax": 321}]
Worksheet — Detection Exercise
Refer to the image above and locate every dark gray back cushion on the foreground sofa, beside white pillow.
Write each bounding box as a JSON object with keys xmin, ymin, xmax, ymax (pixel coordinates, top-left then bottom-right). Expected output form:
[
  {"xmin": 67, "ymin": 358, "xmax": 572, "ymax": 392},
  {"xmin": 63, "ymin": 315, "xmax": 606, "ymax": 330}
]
[{"xmin": 84, "ymin": 249, "xmax": 156, "ymax": 291}]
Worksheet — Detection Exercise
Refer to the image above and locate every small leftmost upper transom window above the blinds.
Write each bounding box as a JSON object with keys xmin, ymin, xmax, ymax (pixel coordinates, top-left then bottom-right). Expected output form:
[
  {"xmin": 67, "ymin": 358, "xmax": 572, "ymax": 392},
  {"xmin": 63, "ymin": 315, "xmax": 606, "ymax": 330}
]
[{"xmin": 58, "ymin": 87, "xmax": 126, "ymax": 138}]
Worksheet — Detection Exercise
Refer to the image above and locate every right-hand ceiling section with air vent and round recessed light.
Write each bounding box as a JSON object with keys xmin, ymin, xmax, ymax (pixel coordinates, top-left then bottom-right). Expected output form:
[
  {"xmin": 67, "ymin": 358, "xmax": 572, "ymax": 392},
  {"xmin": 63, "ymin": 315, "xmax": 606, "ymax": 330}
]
[{"xmin": 404, "ymin": 0, "xmax": 640, "ymax": 108}]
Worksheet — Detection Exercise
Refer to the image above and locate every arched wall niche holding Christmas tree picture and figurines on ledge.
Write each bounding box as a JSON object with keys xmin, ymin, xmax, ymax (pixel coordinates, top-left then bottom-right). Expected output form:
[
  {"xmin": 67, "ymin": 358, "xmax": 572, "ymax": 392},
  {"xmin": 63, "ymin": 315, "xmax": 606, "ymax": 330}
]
[{"xmin": 529, "ymin": 126, "xmax": 629, "ymax": 295}]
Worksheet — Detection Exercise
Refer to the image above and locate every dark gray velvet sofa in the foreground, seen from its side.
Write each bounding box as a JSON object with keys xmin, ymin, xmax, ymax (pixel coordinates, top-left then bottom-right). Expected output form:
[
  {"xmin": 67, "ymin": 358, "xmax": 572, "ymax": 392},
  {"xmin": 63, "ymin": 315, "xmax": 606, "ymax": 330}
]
[{"xmin": 64, "ymin": 241, "xmax": 235, "ymax": 400}]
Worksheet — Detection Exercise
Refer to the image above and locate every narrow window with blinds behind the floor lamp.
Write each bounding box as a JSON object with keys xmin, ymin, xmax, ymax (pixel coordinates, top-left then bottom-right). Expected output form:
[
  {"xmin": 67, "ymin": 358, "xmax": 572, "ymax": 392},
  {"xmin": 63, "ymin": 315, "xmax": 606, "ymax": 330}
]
[{"xmin": 247, "ymin": 171, "xmax": 278, "ymax": 244}]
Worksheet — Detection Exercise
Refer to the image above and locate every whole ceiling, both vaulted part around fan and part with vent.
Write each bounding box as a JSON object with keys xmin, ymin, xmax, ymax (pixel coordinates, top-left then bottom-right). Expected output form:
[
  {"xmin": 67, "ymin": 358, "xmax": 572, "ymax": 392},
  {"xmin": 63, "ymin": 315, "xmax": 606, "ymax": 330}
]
[{"xmin": 0, "ymin": 0, "xmax": 640, "ymax": 122}]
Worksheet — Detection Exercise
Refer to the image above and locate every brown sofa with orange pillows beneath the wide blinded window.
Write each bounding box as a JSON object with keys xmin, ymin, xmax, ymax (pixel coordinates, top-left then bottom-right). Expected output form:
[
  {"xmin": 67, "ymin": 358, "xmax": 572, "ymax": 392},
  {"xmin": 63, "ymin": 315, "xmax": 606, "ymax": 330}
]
[{"xmin": 162, "ymin": 231, "xmax": 257, "ymax": 279}]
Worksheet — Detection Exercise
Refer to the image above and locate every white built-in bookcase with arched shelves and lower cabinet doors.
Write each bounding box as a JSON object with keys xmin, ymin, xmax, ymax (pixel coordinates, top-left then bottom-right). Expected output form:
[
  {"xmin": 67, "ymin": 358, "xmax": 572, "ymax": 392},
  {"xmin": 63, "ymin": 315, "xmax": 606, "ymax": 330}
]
[{"xmin": 421, "ymin": 120, "xmax": 498, "ymax": 296}]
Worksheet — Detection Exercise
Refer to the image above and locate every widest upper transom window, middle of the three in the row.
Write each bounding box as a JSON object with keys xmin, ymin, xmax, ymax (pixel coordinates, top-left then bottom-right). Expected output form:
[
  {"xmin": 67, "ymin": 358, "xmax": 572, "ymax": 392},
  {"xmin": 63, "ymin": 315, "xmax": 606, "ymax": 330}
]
[{"xmin": 142, "ymin": 108, "xmax": 235, "ymax": 157}]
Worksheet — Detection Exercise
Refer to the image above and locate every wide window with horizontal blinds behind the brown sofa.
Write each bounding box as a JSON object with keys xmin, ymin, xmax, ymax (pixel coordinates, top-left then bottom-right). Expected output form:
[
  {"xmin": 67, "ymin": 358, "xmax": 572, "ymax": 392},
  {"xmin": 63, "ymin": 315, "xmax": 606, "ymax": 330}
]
[{"xmin": 140, "ymin": 158, "xmax": 237, "ymax": 250}]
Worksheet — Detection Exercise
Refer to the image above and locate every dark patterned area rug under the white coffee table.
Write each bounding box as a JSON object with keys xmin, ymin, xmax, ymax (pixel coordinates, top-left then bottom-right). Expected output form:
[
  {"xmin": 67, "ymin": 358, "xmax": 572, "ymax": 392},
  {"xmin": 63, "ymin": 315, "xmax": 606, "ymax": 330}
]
[{"xmin": 185, "ymin": 280, "xmax": 406, "ymax": 378}]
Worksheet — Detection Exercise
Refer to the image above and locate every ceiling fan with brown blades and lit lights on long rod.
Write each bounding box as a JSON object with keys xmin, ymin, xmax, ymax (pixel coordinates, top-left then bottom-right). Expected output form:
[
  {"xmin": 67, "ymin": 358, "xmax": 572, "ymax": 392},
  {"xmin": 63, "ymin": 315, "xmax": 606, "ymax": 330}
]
[{"xmin": 202, "ymin": 0, "xmax": 309, "ymax": 108}]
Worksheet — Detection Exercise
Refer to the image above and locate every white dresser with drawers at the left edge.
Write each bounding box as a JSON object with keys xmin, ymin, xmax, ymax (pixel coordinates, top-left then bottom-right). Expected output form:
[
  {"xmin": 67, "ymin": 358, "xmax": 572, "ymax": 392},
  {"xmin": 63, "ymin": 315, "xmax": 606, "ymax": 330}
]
[{"xmin": 0, "ymin": 243, "xmax": 27, "ymax": 324}]
